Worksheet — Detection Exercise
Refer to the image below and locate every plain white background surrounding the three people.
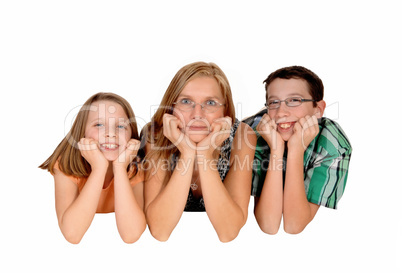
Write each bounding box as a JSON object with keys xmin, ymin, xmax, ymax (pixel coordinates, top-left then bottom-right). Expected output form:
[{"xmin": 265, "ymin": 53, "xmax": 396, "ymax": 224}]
[{"xmin": 0, "ymin": 0, "xmax": 402, "ymax": 272}]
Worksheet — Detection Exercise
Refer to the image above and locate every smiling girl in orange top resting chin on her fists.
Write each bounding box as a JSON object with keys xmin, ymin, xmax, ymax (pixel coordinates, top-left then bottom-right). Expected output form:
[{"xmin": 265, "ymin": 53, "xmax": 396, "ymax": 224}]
[{"xmin": 39, "ymin": 93, "xmax": 146, "ymax": 243}]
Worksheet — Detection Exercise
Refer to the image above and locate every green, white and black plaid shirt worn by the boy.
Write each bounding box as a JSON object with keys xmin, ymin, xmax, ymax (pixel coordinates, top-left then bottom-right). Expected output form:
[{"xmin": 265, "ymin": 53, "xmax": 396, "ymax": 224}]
[{"xmin": 243, "ymin": 110, "xmax": 352, "ymax": 209}]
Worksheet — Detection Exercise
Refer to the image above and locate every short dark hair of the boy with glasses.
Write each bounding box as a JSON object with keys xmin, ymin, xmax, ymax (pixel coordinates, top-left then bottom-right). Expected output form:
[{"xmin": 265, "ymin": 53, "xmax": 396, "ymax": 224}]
[{"xmin": 263, "ymin": 65, "xmax": 324, "ymax": 107}]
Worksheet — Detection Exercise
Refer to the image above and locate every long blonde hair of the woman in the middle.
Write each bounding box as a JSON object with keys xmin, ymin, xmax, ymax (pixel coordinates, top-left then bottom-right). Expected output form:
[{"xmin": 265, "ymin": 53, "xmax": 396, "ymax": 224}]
[{"xmin": 141, "ymin": 62, "xmax": 235, "ymax": 182}]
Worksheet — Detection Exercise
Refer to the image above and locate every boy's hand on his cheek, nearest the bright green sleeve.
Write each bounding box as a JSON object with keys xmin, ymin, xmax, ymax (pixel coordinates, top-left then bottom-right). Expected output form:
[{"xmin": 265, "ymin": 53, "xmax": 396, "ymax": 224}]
[{"xmin": 288, "ymin": 115, "xmax": 319, "ymax": 153}]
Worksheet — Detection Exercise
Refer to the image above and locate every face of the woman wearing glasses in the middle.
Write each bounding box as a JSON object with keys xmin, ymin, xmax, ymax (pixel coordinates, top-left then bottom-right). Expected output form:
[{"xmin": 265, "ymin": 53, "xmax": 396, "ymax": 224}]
[{"xmin": 173, "ymin": 76, "xmax": 225, "ymax": 143}]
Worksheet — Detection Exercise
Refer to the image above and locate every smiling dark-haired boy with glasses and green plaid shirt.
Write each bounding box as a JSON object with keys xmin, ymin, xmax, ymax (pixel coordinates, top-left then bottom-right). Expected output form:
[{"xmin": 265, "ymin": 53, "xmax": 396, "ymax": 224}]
[{"xmin": 243, "ymin": 66, "xmax": 352, "ymax": 234}]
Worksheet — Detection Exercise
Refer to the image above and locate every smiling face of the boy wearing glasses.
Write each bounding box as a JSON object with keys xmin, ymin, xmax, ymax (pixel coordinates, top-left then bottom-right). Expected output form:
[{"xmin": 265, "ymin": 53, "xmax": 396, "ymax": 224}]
[{"xmin": 267, "ymin": 78, "xmax": 325, "ymax": 141}]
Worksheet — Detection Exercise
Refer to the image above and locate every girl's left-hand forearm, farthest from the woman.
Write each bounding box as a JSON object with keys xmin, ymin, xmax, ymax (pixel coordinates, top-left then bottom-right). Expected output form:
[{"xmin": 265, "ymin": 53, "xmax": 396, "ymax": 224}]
[{"xmin": 59, "ymin": 170, "xmax": 106, "ymax": 243}]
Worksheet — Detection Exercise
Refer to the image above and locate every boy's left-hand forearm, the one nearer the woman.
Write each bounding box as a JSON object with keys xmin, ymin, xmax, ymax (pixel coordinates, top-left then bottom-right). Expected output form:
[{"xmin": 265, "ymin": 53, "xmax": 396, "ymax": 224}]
[{"xmin": 254, "ymin": 152, "xmax": 283, "ymax": 234}]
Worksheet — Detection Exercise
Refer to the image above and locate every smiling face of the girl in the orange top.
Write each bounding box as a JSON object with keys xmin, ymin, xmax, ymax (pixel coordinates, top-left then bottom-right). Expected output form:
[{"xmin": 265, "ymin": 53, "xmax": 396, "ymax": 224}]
[{"xmin": 84, "ymin": 101, "xmax": 131, "ymax": 161}]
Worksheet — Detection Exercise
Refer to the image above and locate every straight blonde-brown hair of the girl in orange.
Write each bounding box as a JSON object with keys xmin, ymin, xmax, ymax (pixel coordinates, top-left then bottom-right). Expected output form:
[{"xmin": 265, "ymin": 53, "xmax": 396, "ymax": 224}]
[{"xmin": 39, "ymin": 93, "xmax": 139, "ymax": 178}]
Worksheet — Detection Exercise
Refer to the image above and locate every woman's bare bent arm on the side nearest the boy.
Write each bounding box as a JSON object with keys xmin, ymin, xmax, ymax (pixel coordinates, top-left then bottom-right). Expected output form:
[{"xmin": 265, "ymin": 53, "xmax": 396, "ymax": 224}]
[{"xmin": 198, "ymin": 120, "xmax": 256, "ymax": 242}]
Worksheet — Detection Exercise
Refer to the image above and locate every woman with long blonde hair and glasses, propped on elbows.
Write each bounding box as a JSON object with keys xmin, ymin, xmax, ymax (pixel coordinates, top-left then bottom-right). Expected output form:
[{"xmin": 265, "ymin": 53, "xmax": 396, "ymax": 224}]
[{"xmin": 143, "ymin": 62, "xmax": 256, "ymax": 242}]
